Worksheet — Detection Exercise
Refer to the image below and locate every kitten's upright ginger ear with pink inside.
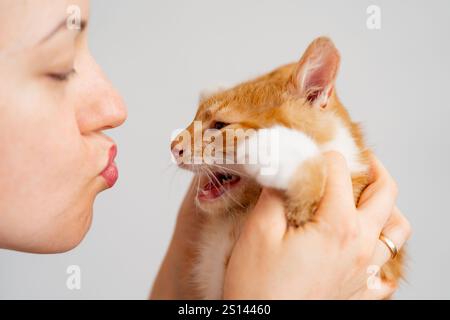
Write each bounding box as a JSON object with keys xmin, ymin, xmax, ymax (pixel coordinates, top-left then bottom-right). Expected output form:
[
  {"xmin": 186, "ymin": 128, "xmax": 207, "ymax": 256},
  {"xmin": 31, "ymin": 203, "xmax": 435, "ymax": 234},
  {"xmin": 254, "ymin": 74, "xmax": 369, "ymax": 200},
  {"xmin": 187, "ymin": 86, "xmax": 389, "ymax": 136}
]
[{"xmin": 290, "ymin": 37, "xmax": 340, "ymax": 108}]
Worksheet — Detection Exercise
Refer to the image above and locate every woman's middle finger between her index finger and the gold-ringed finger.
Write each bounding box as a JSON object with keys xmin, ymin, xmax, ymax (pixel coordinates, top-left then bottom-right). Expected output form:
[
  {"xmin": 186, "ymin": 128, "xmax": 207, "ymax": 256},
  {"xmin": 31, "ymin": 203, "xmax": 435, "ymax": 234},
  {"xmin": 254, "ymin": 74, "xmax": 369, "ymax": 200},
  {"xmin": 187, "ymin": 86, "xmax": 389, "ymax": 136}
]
[{"xmin": 358, "ymin": 156, "xmax": 397, "ymax": 231}]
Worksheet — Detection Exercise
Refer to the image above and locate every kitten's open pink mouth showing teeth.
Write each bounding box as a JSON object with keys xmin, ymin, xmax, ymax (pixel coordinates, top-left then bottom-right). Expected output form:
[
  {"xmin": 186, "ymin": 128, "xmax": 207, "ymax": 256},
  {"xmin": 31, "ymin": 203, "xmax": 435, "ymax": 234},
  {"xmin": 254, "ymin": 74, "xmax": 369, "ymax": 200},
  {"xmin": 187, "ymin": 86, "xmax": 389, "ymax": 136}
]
[{"xmin": 197, "ymin": 172, "xmax": 241, "ymax": 201}]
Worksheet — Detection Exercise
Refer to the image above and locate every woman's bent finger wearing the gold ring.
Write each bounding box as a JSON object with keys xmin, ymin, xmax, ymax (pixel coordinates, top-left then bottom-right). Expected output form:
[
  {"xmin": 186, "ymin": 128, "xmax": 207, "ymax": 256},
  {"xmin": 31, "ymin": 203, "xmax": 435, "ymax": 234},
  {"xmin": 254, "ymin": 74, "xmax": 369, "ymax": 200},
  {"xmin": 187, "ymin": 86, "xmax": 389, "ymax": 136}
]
[{"xmin": 372, "ymin": 207, "xmax": 411, "ymax": 266}]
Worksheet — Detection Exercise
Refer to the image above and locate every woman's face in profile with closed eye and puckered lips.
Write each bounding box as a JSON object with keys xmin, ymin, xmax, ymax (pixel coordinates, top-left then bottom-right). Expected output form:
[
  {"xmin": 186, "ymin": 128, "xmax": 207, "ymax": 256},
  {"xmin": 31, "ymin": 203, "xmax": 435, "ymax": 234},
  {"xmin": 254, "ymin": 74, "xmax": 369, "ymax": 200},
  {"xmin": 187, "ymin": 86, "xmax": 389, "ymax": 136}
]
[{"xmin": 0, "ymin": 0, "xmax": 126, "ymax": 253}]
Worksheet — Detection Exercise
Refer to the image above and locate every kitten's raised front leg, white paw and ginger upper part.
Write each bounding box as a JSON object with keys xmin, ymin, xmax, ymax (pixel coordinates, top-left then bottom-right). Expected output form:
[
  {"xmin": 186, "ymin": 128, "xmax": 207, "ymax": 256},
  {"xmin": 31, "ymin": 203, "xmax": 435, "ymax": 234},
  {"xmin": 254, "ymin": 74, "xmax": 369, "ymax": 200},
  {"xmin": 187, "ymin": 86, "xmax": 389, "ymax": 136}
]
[{"xmin": 239, "ymin": 126, "xmax": 326, "ymax": 226}]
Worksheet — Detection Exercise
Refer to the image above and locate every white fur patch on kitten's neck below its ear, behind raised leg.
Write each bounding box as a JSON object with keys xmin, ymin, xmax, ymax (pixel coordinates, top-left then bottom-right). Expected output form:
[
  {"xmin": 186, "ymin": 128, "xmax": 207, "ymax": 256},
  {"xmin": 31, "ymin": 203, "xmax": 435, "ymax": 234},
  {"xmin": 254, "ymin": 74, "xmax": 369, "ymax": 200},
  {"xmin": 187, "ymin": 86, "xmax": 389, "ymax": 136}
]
[{"xmin": 320, "ymin": 122, "xmax": 368, "ymax": 173}]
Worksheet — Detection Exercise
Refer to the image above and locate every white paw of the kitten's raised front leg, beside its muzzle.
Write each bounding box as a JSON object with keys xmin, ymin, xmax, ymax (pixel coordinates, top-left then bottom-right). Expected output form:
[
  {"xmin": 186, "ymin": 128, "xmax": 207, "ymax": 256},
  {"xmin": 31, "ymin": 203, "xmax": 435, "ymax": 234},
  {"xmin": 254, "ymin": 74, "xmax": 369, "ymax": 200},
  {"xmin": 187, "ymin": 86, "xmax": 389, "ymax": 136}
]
[{"xmin": 238, "ymin": 126, "xmax": 319, "ymax": 190}]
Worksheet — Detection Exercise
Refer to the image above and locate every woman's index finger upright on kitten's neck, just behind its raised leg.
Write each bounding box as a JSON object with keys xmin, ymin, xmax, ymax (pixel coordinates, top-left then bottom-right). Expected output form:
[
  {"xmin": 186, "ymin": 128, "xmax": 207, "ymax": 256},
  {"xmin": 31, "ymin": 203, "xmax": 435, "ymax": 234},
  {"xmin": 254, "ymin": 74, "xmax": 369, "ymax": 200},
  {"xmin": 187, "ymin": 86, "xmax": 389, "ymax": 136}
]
[{"xmin": 317, "ymin": 152, "xmax": 355, "ymax": 221}]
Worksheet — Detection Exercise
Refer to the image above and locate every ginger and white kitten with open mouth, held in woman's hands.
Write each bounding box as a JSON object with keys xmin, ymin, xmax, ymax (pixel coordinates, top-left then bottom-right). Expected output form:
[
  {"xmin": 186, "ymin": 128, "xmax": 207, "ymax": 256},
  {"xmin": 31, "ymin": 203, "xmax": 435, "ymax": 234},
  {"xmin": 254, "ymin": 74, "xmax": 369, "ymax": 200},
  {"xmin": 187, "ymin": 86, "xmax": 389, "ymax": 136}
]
[{"xmin": 172, "ymin": 37, "xmax": 403, "ymax": 299}]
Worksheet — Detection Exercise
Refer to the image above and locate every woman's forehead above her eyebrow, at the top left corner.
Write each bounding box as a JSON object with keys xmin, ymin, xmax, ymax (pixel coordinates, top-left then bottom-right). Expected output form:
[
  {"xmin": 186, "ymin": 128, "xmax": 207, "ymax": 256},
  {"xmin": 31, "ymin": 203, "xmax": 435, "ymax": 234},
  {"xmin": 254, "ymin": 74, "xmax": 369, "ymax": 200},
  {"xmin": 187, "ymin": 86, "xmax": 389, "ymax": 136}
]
[{"xmin": 0, "ymin": 0, "xmax": 89, "ymax": 52}]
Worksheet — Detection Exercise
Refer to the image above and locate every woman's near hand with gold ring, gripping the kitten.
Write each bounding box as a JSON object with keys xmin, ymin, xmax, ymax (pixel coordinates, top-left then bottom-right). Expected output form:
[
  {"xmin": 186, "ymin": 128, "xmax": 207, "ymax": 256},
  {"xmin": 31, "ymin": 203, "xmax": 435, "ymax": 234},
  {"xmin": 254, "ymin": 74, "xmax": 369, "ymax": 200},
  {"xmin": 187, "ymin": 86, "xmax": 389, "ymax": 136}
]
[{"xmin": 224, "ymin": 153, "xmax": 410, "ymax": 299}]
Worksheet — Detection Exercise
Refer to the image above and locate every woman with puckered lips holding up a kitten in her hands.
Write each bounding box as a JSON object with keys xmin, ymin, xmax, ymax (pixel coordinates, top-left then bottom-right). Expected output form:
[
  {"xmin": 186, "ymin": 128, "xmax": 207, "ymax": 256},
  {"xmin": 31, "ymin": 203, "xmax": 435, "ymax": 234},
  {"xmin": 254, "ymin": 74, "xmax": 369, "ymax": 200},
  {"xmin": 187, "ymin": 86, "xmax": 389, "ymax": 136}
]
[{"xmin": 0, "ymin": 0, "xmax": 410, "ymax": 299}]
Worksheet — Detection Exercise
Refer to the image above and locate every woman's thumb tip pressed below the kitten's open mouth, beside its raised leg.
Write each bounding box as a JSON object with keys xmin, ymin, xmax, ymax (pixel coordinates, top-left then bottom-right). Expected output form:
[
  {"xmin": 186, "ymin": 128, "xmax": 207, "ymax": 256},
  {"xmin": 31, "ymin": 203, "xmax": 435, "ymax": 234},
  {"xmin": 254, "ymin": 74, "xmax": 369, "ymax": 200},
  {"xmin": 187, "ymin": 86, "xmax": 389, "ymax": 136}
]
[{"xmin": 246, "ymin": 188, "xmax": 287, "ymax": 239}]
